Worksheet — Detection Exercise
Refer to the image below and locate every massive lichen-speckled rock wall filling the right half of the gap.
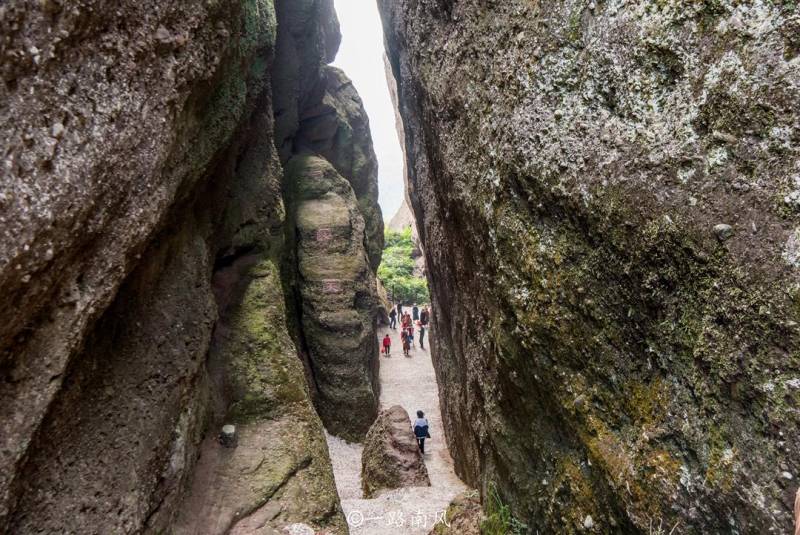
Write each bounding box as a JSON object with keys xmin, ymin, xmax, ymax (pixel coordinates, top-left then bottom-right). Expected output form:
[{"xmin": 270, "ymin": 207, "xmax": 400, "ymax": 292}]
[{"xmin": 379, "ymin": 0, "xmax": 800, "ymax": 533}]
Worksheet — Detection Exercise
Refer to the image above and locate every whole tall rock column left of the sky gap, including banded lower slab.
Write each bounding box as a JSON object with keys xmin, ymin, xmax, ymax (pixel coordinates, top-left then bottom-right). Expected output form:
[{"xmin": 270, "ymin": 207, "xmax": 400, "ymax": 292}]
[{"xmin": 272, "ymin": 0, "xmax": 383, "ymax": 440}]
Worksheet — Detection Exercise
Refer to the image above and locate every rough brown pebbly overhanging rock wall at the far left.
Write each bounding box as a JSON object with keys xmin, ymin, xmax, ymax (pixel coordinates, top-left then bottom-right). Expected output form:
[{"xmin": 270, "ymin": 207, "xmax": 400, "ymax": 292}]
[{"xmin": 0, "ymin": 1, "xmax": 276, "ymax": 532}]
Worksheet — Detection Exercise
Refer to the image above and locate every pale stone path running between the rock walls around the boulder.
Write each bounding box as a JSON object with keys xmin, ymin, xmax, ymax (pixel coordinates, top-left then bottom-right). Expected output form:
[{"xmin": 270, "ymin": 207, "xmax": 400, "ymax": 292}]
[{"xmin": 328, "ymin": 329, "xmax": 467, "ymax": 535}]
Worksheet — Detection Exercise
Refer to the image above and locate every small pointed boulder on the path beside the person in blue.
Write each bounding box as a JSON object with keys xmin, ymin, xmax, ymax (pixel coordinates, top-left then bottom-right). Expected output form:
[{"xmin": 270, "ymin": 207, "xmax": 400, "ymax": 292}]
[{"xmin": 361, "ymin": 405, "xmax": 431, "ymax": 498}]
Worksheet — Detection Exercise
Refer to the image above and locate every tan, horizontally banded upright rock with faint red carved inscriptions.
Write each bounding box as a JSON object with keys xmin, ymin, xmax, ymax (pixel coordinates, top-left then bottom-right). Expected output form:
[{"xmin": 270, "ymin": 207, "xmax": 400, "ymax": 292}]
[{"xmin": 285, "ymin": 154, "xmax": 379, "ymax": 440}]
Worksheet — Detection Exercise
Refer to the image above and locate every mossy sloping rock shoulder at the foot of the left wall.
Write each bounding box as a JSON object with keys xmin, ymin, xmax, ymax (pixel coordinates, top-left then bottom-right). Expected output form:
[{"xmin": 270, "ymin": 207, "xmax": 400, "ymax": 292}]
[{"xmin": 171, "ymin": 257, "xmax": 346, "ymax": 535}]
